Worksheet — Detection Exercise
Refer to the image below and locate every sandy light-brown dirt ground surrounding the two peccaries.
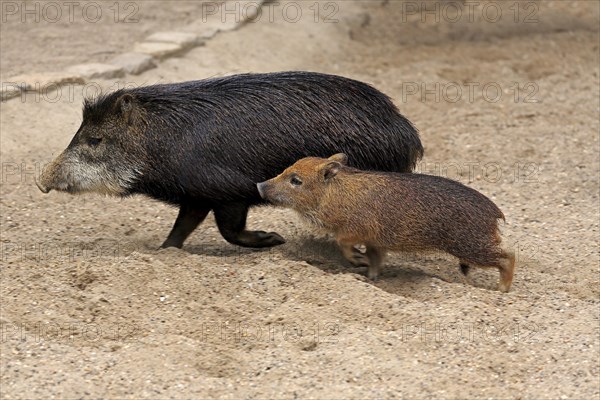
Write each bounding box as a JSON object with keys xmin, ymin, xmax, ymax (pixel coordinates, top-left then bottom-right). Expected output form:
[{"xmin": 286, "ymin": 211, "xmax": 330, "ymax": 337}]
[{"xmin": 0, "ymin": 1, "xmax": 600, "ymax": 399}]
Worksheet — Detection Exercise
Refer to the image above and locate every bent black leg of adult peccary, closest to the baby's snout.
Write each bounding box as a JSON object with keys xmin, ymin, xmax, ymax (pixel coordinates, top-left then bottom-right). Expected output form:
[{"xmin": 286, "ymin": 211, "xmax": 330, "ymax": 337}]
[{"xmin": 214, "ymin": 203, "xmax": 285, "ymax": 248}]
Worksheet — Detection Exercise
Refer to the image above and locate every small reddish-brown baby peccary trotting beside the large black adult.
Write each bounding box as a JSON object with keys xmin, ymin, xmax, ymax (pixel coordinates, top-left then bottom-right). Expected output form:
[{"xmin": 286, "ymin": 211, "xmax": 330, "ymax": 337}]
[{"xmin": 257, "ymin": 154, "xmax": 515, "ymax": 292}]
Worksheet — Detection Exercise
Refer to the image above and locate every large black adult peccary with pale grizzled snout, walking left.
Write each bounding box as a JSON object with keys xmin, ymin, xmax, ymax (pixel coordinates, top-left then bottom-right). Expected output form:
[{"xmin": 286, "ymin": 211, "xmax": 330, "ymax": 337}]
[{"xmin": 38, "ymin": 72, "xmax": 423, "ymax": 247}]
